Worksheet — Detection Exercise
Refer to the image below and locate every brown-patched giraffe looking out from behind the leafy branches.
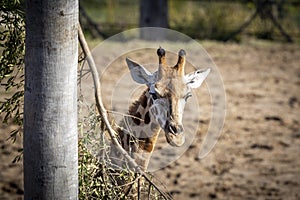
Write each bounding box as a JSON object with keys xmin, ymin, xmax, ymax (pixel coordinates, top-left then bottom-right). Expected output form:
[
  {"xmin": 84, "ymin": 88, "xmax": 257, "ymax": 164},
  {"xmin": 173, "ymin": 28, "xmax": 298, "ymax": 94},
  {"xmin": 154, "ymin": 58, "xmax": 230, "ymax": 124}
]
[{"xmin": 111, "ymin": 47, "xmax": 210, "ymax": 171}]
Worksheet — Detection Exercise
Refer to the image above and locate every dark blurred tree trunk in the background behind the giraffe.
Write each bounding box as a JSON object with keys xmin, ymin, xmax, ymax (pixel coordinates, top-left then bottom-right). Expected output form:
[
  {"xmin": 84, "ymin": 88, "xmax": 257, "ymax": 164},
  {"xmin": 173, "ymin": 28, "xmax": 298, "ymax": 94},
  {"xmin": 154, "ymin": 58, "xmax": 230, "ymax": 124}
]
[{"xmin": 139, "ymin": 0, "xmax": 168, "ymax": 40}]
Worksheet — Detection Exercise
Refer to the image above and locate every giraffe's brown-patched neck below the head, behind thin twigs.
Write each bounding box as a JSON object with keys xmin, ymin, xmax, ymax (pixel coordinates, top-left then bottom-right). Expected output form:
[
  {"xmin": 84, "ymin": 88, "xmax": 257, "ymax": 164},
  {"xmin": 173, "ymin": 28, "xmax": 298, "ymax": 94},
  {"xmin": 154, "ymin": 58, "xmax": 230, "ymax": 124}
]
[{"xmin": 118, "ymin": 90, "xmax": 160, "ymax": 170}]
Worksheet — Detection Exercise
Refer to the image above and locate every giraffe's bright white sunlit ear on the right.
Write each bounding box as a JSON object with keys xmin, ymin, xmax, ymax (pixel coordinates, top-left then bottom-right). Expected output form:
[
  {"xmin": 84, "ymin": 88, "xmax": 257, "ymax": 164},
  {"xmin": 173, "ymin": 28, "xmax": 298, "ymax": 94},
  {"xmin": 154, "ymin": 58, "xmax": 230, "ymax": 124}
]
[{"xmin": 184, "ymin": 68, "xmax": 210, "ymax": 88}]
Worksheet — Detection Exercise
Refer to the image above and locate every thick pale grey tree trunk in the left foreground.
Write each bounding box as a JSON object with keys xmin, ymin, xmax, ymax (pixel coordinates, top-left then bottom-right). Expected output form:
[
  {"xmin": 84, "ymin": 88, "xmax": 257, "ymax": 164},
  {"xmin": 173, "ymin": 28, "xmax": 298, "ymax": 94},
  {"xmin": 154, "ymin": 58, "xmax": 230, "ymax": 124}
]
[{"xmin": 23, "ymin": 0, "xmax": 78, "ymax": 200}]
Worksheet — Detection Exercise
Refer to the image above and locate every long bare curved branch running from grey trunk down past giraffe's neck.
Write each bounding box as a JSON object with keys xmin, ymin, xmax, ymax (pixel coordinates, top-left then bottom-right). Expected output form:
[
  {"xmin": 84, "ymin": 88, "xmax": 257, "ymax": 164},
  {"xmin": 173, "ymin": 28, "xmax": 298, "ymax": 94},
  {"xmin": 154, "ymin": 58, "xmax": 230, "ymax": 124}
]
[{"xmin": 78, "ymin": 24, "xmax": 172, "ymax": 199}]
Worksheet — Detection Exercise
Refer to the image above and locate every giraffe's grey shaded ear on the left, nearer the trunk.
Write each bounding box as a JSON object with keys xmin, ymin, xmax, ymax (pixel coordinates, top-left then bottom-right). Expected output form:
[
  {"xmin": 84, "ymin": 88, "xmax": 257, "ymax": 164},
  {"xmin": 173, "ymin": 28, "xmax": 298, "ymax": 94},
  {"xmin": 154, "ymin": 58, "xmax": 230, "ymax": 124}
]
[{"xmin": 126, "ymin": 58, "xmax": 155, "ymax": 85}]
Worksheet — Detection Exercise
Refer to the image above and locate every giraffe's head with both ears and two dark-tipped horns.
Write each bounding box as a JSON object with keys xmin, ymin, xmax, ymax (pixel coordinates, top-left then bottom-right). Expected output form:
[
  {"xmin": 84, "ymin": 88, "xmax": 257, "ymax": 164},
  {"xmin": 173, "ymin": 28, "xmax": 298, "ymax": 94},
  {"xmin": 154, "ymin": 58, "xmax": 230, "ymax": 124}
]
[{"xmin": 126, "ymin": 48, "xmax": 210, "ymax": 146}]
